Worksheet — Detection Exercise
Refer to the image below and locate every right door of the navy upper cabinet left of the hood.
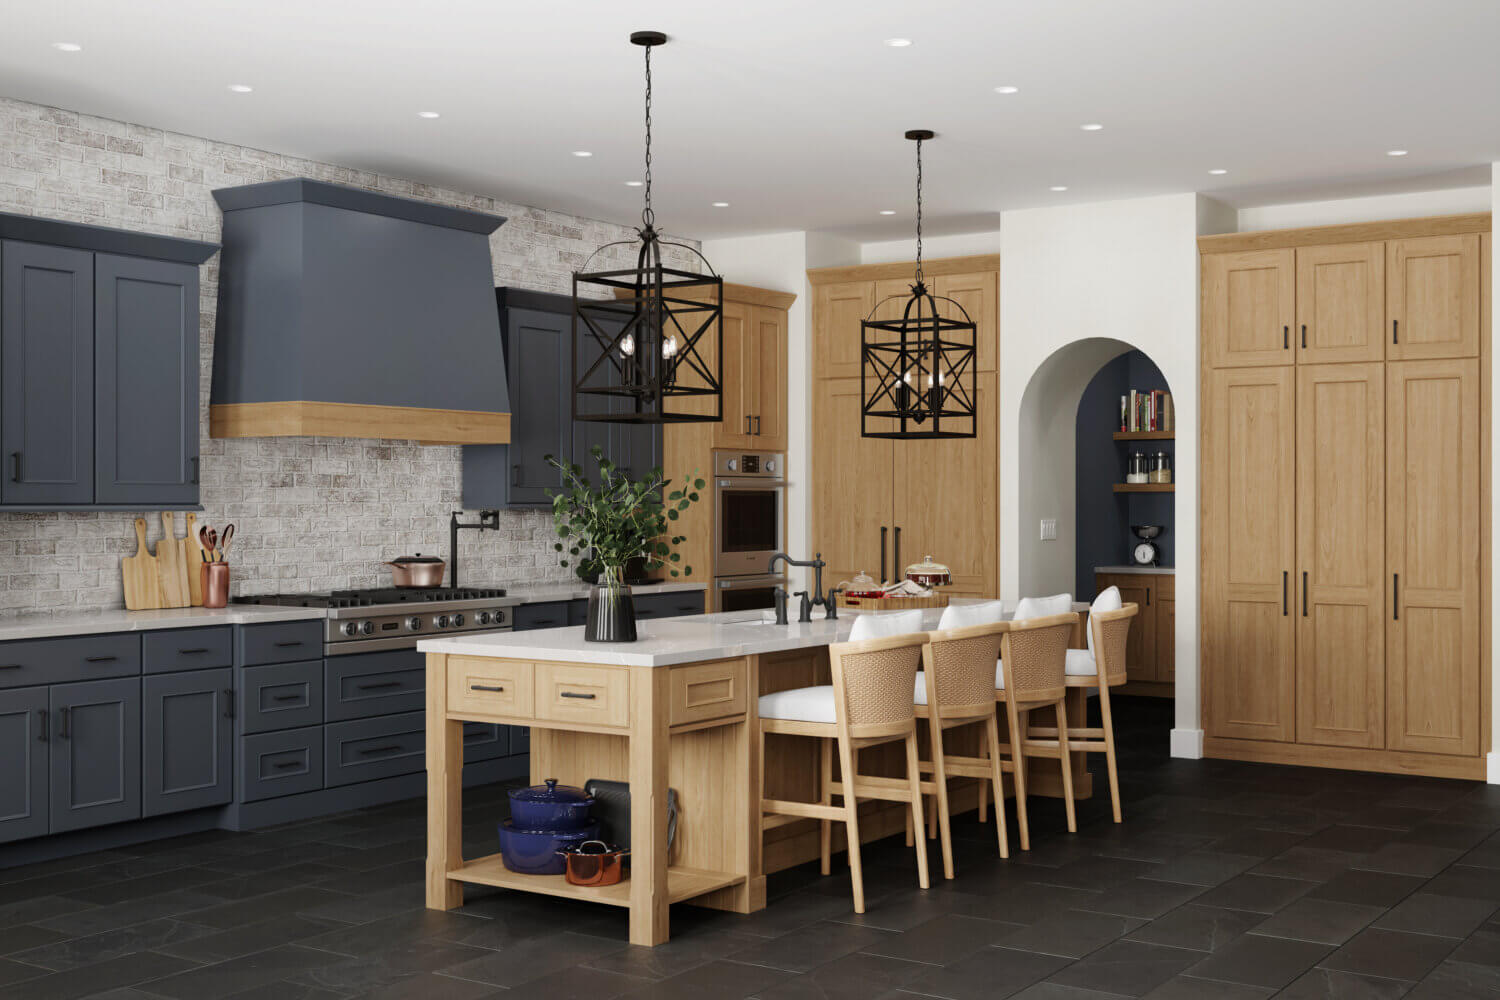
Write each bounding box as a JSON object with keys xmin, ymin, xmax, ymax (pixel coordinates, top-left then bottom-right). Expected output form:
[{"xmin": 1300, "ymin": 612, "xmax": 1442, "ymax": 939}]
[{"xmin": 95, "ymin": 253, "xmax": 198, "ymax": 504}]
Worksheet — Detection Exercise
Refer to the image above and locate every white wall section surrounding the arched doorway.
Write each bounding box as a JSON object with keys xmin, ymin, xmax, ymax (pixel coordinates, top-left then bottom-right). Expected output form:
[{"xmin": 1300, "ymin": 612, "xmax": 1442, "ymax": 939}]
[{"xmin": 1001, "ymin": 193, "xmax": 1227, "ymax": 756}]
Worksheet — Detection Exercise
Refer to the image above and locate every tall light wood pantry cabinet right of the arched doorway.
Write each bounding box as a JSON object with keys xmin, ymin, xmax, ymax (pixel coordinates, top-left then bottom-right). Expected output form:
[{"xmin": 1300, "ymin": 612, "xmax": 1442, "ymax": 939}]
[{"xmin": 1199, "ymin": 214, "xmax": 1491, "ymax": 778}]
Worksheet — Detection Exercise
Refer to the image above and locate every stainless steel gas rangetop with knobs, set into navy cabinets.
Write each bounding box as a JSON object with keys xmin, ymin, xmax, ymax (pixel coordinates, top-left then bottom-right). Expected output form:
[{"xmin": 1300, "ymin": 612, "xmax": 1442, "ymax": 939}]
[{"xmin": 234, "ymin": 588, "xmax": 518, "ymax": 657}]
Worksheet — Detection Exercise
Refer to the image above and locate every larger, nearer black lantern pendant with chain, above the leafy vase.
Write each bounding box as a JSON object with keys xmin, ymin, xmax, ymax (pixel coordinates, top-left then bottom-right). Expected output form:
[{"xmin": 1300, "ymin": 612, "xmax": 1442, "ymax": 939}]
[{"xmin": 573, "ymin": 31, "xmax": 725, "ymax": 424}]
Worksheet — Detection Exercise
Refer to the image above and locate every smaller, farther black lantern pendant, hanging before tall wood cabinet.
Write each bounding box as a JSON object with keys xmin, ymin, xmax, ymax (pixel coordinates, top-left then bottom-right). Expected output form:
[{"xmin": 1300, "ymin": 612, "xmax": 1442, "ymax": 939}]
[{"xmin": 860, "ymin": 129, "xmax": 978, "ymax": 439}]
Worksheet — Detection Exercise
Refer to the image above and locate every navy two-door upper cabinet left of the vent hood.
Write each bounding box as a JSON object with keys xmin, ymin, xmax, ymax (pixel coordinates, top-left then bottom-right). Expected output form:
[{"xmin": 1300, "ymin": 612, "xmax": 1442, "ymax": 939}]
[{"xmin": 0, "ymin": 213, "xmax": 218, "ymax": 510}]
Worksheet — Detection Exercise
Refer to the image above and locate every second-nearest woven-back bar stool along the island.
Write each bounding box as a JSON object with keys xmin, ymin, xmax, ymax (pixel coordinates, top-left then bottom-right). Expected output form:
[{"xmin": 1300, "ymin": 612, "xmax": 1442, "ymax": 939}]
[{"xmin": 906, "ymin": 622, "xmax": 1011, "ymax": 879}]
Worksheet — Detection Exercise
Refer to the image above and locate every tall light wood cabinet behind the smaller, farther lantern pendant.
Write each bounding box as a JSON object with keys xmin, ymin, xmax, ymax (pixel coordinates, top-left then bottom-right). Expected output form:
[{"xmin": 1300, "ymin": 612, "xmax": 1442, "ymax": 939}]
[{"xmin": 807, "ymin": 256, "xmax": 999, "ymax": 597}]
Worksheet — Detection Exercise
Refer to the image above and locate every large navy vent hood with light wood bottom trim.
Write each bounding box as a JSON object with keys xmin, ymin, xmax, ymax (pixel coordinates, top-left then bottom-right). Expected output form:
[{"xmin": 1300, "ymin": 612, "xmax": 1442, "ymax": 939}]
[{"xmin": 209, "ymin": 177, "xmax": 510, "ymax": 444}]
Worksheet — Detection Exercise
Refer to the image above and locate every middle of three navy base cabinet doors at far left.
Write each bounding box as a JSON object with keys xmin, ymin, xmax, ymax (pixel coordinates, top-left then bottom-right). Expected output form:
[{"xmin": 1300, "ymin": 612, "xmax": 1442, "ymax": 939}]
[{"xmin": 48, "ymin": 678, "xmax": 141, "ymax": 834}]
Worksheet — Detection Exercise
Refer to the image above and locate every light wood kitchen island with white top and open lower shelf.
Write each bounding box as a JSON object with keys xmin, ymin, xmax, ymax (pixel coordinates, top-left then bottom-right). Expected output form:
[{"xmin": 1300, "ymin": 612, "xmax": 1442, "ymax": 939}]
[{"xmin": 419, "ymin": 604, "xmax": 1089, "ymax": 945}]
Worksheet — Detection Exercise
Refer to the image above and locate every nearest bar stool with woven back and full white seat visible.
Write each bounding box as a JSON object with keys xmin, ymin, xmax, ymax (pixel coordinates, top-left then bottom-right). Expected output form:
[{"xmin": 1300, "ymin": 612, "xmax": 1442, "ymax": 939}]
[{"xmin": 759, "ymin": 633, "xmax": 932, "ymax": 913}]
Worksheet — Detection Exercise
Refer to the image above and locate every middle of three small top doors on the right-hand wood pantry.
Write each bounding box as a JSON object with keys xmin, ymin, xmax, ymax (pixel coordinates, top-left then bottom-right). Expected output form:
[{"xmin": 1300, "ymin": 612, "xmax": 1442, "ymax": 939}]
[{"xmin": 1296, "ymin": 243, "xmax": 1386, "ymax": 364}]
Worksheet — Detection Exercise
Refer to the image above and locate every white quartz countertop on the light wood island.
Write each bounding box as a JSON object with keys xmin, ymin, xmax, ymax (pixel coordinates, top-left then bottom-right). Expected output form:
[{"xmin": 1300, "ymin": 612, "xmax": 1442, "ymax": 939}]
[{"xmin": 417, "ymin": 601, "xmax": 1089, "ymax": 667}]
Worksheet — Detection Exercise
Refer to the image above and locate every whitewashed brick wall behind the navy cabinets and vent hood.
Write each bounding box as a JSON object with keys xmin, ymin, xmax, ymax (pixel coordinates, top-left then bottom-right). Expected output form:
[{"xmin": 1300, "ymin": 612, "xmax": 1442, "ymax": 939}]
[{"xmin": 0, "ymin": 97, "xmax": 698, "ymax": 618}]
